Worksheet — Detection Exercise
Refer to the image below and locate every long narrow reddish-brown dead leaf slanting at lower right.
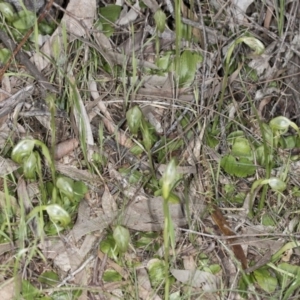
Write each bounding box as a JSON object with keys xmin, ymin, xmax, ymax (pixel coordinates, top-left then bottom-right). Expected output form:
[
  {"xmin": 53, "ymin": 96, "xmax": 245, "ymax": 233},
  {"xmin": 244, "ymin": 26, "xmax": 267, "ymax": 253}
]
[{"xmin": 211, "ymin": 205, "xmax": 248, "ymax": 270}]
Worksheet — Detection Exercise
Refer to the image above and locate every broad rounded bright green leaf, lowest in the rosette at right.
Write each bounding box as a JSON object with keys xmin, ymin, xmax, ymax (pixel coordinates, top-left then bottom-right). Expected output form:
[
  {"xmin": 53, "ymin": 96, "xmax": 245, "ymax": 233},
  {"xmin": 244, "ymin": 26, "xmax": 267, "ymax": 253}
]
[{"xmin": 221, "ymin": 155, "xmax": 256, "ymax": 177}]
